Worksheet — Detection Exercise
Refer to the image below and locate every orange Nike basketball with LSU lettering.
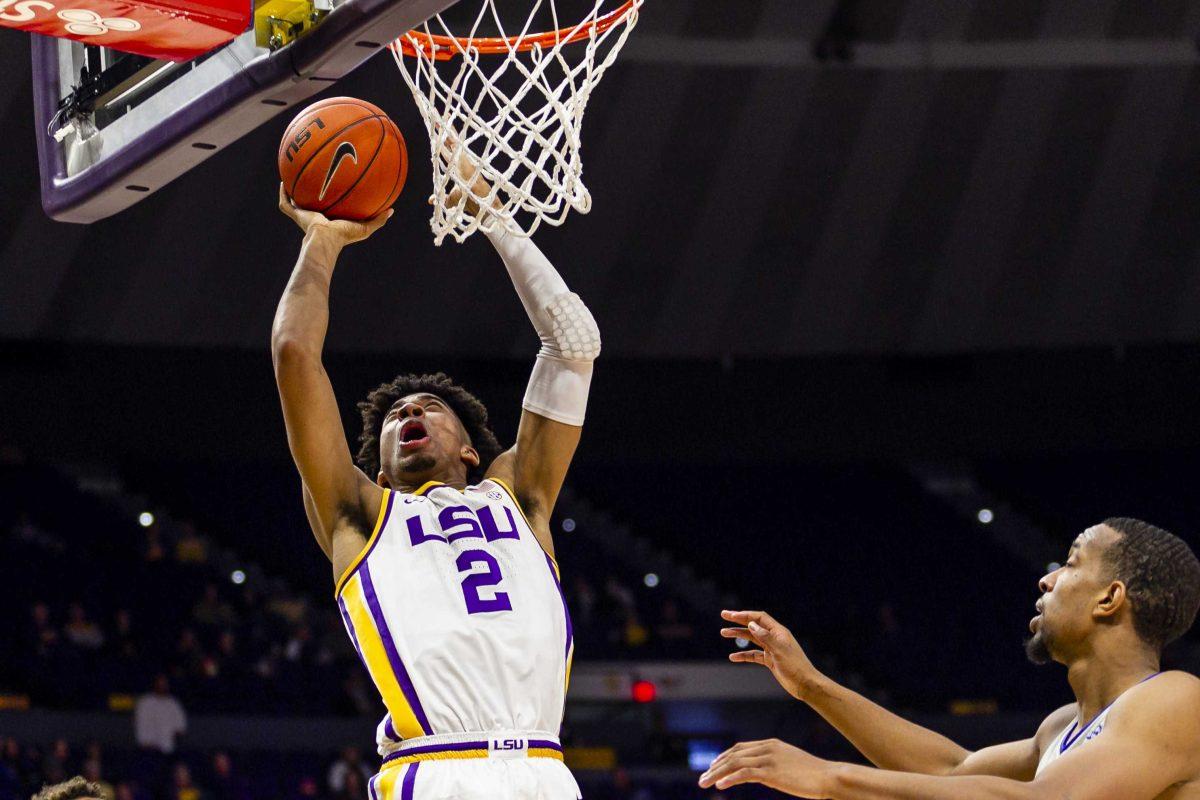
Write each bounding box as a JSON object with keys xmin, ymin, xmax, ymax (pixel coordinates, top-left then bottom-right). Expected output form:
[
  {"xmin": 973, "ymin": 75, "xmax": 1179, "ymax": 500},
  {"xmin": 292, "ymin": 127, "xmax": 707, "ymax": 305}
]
[{"xmin": 278, "ymin": 97, "xmax": 408, "ymax": 219}]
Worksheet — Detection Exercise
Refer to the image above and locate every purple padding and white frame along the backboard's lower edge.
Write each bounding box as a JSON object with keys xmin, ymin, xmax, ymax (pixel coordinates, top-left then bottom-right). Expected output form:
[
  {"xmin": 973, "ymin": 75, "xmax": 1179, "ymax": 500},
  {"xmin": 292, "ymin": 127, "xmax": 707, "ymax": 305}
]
[{"xmin": 32, "ymin": 0, "xmax": 455, "ymax": 223}]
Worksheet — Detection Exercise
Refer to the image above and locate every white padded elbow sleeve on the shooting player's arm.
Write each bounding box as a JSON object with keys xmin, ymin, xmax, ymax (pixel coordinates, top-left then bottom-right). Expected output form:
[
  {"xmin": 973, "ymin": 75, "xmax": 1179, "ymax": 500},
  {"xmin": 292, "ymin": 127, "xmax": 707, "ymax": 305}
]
[{"xmin": 488, "ymin": 226, "xmax": 600, "ymax": 426}]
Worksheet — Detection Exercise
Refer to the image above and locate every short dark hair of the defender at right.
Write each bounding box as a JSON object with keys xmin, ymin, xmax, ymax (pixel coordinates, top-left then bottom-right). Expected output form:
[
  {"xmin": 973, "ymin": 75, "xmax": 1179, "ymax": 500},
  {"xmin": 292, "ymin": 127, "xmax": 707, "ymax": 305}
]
[{"xmin": 1104, "ymin": 517, "xmax": 1200, "ymax": 649}]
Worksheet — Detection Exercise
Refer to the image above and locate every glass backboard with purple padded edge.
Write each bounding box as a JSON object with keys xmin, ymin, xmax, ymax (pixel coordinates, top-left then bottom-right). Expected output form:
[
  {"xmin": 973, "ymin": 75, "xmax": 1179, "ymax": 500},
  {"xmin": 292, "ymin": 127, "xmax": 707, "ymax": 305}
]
[{"xmin": 32, "ymin": 0, "xmax": 455, "ymax": 223}]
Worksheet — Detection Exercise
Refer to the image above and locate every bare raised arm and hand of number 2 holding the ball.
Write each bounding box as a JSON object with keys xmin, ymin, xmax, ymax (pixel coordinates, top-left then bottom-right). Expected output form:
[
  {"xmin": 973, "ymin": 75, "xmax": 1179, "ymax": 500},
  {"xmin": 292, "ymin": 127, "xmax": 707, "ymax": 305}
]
[{"xmin": 271, "ymin": 186, "xmax": 390, "ymax": 569}]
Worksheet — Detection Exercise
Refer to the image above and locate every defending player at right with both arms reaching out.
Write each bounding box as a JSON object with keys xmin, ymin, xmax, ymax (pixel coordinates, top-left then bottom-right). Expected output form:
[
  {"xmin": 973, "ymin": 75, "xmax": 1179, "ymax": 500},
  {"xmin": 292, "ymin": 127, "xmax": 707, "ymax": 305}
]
[{"xmin": 700, "ymin": 519, "xmax": 1200, "ymax": 800}]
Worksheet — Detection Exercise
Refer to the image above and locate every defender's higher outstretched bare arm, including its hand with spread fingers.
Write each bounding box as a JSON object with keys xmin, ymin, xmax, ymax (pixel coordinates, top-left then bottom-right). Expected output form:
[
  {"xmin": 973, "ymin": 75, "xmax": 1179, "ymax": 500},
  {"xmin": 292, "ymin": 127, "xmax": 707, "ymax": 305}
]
[{"xmin": 721, "ymin": 610, "xmax": 1051, "ymax": 781}]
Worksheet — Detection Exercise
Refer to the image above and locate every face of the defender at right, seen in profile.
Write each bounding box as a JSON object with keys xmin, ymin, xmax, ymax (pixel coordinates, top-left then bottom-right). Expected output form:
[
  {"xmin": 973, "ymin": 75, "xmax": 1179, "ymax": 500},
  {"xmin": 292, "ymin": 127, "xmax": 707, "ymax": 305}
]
[{"xmin": 1025, "ymin": 525, "xmax": 1120, "ymax": 663}]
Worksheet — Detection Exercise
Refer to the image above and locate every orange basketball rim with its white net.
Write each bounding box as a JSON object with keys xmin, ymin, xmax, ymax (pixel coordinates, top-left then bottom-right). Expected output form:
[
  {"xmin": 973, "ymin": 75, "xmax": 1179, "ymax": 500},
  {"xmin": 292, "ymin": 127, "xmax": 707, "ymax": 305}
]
[{"xmin": 389, "ymin": 0, "xmax": 642, "ymax": 245}]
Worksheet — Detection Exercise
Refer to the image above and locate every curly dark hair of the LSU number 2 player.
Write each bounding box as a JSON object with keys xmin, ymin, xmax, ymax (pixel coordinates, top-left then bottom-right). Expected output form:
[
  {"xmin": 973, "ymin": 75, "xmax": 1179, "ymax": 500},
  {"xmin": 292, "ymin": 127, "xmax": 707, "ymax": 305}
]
[{"xmin": 356, "ymin": 372, "xmax": 502, "ymax": 483}]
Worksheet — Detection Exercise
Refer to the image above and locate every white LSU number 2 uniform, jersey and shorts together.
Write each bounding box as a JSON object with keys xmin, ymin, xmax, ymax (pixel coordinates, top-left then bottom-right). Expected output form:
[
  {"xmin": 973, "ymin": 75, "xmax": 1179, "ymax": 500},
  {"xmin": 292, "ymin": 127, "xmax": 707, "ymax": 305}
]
[{"xmin": 335, "ymin": 479, "xmax": 578, "ymax": 800}]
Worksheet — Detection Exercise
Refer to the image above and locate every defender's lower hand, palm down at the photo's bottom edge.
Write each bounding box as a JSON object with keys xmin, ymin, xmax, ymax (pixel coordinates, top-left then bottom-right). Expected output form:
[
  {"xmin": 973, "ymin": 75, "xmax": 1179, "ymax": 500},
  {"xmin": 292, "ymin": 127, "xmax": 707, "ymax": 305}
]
[{"xmin": 700, "ymin": 739, "xmax": 834, "ymax": 800}]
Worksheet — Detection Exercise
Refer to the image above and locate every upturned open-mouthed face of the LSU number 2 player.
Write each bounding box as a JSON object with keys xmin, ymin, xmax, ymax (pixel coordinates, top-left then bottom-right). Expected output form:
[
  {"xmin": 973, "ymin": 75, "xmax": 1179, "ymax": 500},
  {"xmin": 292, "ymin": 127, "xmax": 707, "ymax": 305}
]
[{"xmin": 379, "ymin": 393, "xmax": 479, "ymax": 487}]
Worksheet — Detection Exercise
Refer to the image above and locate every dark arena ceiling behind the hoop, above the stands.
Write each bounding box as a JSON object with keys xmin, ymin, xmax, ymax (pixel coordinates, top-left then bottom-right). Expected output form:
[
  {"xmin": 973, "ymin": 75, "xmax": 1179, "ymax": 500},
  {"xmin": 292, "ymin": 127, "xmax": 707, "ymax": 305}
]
[{"xmin": 0, "ymin": 0, "xmax": 1200, "ymax": 357}]
